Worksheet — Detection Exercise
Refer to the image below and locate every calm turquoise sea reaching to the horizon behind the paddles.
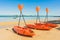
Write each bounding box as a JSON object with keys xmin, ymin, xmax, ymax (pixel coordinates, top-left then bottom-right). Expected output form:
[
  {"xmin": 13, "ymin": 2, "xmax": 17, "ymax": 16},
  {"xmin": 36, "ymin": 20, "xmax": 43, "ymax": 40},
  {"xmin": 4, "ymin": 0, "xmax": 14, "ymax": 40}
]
[{"xmin": 0, "ymin": 15, "xmax": 60, "ymax": 22}]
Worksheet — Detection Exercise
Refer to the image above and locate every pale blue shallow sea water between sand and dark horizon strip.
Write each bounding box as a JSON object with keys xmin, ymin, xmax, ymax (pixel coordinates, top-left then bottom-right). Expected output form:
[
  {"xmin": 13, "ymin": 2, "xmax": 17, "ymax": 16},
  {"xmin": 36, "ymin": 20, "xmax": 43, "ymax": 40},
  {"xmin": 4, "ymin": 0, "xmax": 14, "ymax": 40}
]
[{"xmin": 0, "ymin": 16, "xmax": 60, "ymax": 22}]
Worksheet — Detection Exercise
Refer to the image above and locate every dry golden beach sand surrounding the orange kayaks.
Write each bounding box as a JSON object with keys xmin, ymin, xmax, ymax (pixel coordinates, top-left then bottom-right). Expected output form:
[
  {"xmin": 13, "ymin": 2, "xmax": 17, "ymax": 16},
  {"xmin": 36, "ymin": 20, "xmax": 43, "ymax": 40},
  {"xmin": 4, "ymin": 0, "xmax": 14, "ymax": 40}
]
[{"xmin": 0, "ymin": 21, "xmax": 60, "ymax": 40}]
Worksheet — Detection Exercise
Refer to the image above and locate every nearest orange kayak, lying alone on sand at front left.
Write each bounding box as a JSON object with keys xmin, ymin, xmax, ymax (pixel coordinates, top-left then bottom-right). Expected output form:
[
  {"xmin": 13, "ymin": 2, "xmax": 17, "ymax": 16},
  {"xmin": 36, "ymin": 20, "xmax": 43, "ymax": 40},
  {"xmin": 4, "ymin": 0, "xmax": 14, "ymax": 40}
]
[{"xmin": 13, "ymin": 26, "xmax": 34, "ymax": 37}]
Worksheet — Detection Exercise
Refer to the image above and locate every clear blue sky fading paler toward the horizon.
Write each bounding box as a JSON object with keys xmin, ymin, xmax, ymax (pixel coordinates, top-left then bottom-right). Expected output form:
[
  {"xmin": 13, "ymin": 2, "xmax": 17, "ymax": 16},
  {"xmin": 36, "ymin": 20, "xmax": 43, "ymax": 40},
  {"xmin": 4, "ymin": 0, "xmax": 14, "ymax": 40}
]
[{"xmin": 0, "ymin": 0, "xmax": 60, "ymax": 16}]
